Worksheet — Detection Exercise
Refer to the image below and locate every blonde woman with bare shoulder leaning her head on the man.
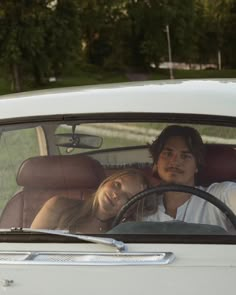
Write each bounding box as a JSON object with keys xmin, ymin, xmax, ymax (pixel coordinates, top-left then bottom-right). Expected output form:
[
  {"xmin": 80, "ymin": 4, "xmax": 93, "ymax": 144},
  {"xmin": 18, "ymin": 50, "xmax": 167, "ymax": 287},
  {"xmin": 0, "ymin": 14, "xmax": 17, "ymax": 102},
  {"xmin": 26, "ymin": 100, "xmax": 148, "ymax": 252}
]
[{"xmin": 31, "ymin": 170, "xmax": 149, "ymax": 233}]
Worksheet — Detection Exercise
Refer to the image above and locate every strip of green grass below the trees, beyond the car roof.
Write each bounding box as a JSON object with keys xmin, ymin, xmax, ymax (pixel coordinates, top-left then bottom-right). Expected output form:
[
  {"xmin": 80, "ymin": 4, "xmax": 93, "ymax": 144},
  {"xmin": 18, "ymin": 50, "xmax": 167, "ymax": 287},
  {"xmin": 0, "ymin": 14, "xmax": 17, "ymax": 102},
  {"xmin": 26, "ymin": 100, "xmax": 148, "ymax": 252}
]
[{"xmin": 0, "ymin": 66, "xmax": 236, "ymax": 95}]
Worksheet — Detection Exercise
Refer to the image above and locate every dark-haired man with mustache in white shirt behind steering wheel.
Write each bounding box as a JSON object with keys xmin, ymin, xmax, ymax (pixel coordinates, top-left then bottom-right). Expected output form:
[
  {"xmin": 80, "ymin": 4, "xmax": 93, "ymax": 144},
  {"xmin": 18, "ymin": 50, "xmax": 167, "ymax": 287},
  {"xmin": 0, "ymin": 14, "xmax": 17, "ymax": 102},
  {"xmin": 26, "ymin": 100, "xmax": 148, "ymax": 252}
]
[{"xmin": 144, "ymin": 125, "xmax": 236, "ymax": 230}]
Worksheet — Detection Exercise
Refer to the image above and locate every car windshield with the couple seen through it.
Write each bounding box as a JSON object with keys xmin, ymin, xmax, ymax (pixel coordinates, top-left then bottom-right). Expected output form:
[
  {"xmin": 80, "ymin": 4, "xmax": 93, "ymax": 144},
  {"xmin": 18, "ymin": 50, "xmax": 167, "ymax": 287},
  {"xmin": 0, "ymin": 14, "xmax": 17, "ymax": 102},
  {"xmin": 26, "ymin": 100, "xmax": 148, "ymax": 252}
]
[{"xmin": 0, "ymin": 118, "xmax": 236, "ymax": 241}]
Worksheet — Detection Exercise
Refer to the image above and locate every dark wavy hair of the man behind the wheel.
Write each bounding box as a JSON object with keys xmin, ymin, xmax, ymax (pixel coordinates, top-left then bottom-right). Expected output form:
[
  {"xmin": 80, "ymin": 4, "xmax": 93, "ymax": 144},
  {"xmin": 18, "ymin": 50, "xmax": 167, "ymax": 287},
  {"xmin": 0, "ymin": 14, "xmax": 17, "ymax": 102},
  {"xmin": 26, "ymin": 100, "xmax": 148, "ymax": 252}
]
[{"xmin": 149, "ymin": 125, "xmax": 205, "ymax": 169}]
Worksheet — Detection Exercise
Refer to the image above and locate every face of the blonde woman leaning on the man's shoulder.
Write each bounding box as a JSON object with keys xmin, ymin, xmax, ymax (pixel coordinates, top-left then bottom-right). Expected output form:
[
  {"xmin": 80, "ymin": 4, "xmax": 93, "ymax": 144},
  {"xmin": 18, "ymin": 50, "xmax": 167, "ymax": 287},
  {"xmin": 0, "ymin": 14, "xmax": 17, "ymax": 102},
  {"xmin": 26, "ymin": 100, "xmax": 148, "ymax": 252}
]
[{"xmin": 97, "ymin": 174, "xmax": 145, "ymax": 218}]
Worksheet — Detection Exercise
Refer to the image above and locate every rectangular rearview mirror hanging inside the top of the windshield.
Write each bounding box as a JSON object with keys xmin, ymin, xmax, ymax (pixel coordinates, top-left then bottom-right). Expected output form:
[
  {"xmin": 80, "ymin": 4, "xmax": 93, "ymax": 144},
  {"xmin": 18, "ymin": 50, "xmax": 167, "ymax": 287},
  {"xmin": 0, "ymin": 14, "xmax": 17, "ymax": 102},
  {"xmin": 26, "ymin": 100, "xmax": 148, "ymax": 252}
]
[{"xmin": 55, "ymin": 133, "xmax": 103, "ymax": 149}]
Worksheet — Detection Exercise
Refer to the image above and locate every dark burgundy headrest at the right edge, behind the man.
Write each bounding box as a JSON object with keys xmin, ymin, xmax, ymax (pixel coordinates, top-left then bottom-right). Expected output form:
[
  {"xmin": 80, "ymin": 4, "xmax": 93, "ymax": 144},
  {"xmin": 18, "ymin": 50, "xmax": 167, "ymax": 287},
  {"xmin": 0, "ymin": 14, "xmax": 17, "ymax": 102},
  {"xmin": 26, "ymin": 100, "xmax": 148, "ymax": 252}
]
[{"xmin": 197, "ymin": 144, "xmax": 236, "ymax": 185}]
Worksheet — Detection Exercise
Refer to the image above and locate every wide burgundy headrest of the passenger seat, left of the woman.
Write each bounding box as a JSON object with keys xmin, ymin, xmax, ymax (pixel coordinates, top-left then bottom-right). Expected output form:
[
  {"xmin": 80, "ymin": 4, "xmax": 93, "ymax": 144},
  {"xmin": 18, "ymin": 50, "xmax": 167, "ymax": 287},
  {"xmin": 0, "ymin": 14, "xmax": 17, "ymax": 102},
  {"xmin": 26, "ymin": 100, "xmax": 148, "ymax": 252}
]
[{"xmin": 17, "ymin": 155, "xmax": 105, "ymax": 189}]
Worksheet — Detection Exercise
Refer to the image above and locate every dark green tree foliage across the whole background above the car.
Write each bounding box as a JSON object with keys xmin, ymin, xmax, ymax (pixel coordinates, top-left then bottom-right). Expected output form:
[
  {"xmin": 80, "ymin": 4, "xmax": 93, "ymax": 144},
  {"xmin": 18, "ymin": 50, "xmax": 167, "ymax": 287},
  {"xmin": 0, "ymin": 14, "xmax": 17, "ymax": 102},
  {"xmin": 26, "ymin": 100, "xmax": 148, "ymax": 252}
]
[{"xmin": 0, "ymin": 0, "xmax": 236, "ymax": 91}]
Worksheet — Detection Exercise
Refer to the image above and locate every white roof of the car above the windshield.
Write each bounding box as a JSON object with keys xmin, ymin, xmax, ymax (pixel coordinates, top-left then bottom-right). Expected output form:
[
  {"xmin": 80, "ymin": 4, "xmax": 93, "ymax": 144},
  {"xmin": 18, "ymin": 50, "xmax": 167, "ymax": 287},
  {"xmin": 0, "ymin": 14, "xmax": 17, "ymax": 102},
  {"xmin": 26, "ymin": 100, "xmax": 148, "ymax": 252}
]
[{"xmin": 0, "ymin": 80, "xmax": 236, "ymax": 119}]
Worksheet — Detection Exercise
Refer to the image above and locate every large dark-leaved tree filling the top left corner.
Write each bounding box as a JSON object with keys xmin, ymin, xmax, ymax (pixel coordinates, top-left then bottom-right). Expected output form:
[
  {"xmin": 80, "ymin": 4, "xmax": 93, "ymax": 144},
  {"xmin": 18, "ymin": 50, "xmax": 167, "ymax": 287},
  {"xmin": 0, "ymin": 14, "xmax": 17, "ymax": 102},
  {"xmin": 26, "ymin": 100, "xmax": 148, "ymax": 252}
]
[{"xmin": 0, "ymin": 0, "xmax": 80, "ymax": 91}]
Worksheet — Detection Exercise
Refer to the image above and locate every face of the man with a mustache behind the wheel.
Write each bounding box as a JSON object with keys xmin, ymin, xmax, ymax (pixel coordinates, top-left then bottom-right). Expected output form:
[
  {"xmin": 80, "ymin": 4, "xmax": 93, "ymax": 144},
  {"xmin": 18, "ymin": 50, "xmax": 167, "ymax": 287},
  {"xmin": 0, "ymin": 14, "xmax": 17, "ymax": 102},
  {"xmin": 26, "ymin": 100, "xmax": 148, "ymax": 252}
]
[{"xmin": 154, "ymin": 136, "xmax": 198, "ymax": 186}]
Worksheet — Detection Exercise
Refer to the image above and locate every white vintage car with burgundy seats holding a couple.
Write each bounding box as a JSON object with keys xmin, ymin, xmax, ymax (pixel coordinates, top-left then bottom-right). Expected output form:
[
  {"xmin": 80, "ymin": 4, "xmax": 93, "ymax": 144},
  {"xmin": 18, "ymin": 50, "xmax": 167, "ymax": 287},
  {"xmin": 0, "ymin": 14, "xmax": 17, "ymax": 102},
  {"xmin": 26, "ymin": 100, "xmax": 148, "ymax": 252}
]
[{"xmin": 0, "ymin": 80, "xmax": 236, "ymax": 295}]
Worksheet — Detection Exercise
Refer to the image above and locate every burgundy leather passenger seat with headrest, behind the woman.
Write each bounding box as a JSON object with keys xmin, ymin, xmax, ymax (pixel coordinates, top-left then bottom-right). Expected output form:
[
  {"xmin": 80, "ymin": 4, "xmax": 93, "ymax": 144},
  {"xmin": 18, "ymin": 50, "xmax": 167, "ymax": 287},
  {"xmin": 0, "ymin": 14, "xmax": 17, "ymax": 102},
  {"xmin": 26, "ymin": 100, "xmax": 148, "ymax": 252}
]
[{"xmin": 0, "ymin": 155, "xmax": 105, "ymax": 228}]
